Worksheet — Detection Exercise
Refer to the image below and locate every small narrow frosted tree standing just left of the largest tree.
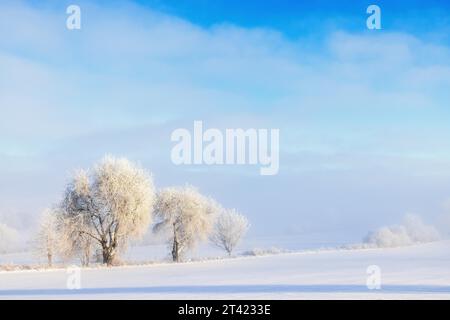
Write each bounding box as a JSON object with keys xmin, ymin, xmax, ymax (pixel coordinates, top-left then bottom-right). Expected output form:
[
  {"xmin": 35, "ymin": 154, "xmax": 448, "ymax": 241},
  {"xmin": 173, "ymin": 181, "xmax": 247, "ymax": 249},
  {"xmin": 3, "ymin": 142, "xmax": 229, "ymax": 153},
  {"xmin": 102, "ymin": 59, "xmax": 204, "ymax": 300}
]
[{"xmin": 35, "ymin": 209, "xmax": 61, "ymax": 267}]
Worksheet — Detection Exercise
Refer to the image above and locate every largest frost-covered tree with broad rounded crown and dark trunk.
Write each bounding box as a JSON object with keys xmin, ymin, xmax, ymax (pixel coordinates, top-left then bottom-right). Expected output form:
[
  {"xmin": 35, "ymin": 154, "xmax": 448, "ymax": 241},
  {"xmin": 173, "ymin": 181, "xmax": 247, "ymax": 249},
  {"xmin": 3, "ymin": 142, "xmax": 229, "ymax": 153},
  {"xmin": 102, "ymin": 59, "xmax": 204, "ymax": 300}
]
[{"xmin": 61, "ymin": 156, "xmax": 155, "ymax": 265}]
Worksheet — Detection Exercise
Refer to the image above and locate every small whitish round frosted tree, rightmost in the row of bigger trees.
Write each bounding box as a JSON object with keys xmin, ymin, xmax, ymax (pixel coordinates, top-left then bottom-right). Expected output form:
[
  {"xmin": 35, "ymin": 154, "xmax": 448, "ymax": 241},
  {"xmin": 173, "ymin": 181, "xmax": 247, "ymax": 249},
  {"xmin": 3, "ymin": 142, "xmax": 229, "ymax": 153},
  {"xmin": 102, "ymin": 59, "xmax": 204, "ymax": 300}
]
[{"xmin": 210, "ymin": 209, "xmax": 250, "ymax": 255}]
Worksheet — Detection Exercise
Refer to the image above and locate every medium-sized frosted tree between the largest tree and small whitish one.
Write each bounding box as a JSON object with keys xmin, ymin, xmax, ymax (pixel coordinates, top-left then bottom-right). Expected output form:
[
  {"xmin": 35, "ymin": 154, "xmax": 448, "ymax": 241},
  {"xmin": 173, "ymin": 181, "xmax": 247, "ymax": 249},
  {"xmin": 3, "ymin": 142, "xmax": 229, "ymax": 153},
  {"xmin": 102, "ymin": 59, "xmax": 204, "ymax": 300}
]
[{"xmin": 153, "ymin": 186, "xmax": 218, "ymax": 262}]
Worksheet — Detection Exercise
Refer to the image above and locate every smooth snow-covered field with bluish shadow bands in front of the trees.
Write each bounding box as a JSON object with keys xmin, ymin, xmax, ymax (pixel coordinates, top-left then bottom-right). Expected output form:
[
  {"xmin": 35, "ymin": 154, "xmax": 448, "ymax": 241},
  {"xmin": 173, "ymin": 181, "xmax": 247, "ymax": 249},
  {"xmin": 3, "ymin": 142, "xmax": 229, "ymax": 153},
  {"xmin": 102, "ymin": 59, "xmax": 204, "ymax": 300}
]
[{"xmin": 0, "ymin": 241, "xmax": 450, "ymax": 299}]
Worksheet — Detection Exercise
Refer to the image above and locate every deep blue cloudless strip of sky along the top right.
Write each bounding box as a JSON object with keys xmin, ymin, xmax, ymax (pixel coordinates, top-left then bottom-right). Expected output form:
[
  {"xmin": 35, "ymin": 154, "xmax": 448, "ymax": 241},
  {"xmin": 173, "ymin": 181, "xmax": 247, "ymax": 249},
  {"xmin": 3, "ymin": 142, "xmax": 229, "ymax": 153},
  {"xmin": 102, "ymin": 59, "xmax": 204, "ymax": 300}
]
[{"xmin": 138, "ymin": 0, "xmax": 449, "ymax": 38}]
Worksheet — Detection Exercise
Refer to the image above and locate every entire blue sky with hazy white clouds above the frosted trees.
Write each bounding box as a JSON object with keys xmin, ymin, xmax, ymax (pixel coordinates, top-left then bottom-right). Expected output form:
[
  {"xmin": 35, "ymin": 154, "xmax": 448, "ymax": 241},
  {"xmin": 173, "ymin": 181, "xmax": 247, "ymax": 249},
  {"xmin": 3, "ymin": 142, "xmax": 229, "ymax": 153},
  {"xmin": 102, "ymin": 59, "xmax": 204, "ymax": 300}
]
[{"xmin": 0, "ymin": 0, "xmax": 450, "ymax": 238}]
